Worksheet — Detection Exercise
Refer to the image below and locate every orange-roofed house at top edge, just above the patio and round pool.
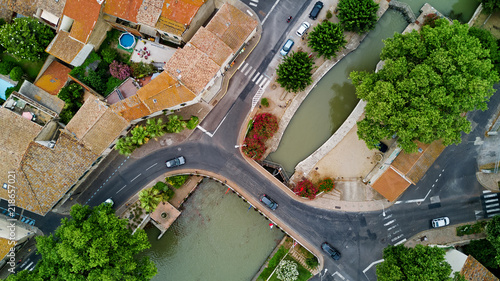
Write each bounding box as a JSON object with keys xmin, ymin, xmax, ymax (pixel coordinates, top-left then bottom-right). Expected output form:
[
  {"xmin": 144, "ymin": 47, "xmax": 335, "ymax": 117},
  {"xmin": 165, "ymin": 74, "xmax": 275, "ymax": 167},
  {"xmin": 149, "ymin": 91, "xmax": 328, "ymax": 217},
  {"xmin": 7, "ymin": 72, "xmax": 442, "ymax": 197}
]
[{"xmin": 102, "ymin": 0, "xmax": 215, "ymax": 45}]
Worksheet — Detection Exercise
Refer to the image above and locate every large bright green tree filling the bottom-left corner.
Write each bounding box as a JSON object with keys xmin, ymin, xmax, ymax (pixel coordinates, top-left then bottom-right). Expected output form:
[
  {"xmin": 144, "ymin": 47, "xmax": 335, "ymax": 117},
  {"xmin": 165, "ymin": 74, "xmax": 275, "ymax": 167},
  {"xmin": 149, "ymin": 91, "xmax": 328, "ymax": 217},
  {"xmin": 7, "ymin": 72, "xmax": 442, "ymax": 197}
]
[{"xmin": 7, "ymin": 204, "xmax": 157, "ymax": 281}]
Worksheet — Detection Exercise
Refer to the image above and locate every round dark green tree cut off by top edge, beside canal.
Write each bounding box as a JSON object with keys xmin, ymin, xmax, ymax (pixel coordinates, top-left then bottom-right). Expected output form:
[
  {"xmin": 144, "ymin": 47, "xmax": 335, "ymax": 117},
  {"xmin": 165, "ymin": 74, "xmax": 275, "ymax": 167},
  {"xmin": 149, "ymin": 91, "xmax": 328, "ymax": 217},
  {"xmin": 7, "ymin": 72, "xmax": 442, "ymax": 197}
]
[{"xmin": 337, "ymin": 0, "xmax": 379, "ymax": 34}]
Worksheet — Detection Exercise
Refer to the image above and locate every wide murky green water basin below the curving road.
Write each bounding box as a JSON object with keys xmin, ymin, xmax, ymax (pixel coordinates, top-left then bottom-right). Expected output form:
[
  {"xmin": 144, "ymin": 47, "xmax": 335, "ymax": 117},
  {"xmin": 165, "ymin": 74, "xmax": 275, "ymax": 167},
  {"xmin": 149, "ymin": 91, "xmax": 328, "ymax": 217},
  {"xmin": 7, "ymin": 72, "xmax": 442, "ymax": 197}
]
[{"xmin": 144, "ymin": 180, "xmax": 284, "ymax": 281}]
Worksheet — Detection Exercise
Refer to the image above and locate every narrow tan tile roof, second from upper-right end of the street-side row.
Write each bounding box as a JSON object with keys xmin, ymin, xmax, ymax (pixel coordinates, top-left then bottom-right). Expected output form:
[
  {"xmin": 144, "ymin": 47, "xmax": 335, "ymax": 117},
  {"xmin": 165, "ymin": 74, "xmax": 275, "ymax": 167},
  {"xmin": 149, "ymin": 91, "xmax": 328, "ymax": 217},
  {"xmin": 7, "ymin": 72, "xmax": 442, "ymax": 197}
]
[{"xmin": 189, "ymin": 27, "xmax": 233, "ymax": 66}]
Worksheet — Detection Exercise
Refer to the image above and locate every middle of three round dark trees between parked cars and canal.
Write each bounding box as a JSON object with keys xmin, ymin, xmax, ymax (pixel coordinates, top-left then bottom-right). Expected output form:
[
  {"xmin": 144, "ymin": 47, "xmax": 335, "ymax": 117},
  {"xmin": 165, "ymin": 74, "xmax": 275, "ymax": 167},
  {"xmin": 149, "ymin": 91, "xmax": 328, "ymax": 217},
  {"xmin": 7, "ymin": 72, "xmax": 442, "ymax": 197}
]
[{"xmin": 307, "ymin": 21, "xmax": 347, "ymax": 59}]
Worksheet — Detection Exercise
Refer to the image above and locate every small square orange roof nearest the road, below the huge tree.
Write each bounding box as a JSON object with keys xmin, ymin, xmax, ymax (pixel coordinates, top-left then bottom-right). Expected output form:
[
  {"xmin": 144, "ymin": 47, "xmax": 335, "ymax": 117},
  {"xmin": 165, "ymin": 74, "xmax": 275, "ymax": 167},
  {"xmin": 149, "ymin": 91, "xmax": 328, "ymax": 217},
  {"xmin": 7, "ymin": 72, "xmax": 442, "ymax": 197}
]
[{"xmin": 371, "ymin": 167, "xmax": 411, "ymax": 201}]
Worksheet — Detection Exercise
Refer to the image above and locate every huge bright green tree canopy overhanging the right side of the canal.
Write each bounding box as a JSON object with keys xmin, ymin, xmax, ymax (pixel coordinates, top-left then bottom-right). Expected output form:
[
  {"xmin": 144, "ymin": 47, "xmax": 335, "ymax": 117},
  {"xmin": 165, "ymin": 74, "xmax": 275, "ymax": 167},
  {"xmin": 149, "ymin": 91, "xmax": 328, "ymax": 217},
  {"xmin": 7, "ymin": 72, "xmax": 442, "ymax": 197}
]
[{"xmin": 350, "ymin": 19, "xmax": 498, "ymax": 152}]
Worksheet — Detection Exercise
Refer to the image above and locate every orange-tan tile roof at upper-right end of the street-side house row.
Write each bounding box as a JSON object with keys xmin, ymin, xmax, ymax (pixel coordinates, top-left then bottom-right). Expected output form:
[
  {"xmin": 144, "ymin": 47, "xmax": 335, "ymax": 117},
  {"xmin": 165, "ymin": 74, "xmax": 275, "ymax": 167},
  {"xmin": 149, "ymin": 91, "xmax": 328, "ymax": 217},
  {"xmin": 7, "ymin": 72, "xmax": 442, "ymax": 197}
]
[{"xmin": 206, "ymin": 3, "xmax": 257, "ymax": 52}]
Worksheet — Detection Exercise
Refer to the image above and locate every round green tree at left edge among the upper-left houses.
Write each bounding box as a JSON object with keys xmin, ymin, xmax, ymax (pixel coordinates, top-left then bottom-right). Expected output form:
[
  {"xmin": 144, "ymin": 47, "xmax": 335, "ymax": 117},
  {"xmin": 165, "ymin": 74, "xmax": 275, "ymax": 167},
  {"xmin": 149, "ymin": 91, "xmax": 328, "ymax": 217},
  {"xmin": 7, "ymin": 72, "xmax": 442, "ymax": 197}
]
[{"xmin": 0, "ymin": 17, "xmax": 54, "ymax": 61}]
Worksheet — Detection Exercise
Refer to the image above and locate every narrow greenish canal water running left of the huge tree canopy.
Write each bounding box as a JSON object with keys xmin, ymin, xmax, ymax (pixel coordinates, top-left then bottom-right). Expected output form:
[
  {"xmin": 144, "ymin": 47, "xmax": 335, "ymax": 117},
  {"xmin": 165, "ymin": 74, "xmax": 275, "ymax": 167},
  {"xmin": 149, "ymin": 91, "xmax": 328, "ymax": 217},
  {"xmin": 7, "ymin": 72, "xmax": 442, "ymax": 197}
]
[{"xmin": 267, "ymin": 0, "xmax": 478, "ymax": 174}]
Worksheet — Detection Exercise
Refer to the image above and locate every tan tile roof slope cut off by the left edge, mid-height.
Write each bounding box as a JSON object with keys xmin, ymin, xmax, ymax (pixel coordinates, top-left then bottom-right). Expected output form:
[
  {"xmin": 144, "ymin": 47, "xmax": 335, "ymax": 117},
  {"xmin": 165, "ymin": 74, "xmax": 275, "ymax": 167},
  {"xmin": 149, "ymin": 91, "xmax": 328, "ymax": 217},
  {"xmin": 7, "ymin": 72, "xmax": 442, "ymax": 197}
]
[{"xmin": 0, "ymin": 107, "xmax": 42, "ymax": 190}]
